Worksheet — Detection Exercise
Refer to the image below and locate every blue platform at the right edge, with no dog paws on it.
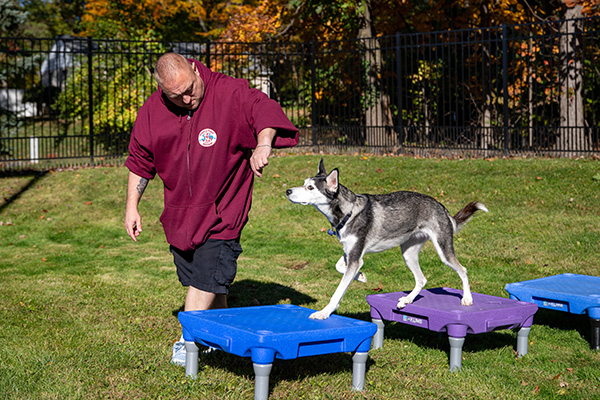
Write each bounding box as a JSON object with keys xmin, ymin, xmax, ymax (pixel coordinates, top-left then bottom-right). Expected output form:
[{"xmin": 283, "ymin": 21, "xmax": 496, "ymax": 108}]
[{"xmin": 505, "ymin": 274, "xmax": 600, "ymax": 350}]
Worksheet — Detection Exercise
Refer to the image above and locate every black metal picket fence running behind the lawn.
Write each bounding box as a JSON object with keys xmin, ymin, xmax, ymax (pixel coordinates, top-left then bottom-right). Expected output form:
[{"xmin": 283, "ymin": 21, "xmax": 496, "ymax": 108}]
[{"xmin": 0, "ymin": 18, "xmax": 600, "ymax": 170}]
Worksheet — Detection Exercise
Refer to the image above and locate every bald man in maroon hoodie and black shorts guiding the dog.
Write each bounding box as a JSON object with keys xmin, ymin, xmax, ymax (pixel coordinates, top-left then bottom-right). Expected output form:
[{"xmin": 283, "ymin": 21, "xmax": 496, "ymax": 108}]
[{"xmin": 125, "ymin": 53, "xmax": 298, "ymax": 365}]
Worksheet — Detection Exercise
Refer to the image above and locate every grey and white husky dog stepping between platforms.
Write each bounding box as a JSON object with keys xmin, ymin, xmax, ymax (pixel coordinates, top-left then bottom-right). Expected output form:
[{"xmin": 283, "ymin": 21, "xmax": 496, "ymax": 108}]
[{"xmin": 286, "ymin": 159, "xmax": 488, "ymax": 319}]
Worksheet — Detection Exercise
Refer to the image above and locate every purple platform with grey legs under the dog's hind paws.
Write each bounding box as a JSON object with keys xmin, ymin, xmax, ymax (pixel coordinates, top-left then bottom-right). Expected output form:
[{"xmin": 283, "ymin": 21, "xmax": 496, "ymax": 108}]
[{"xmin": 367, "ymin": 288, "xmax": 538, "ymax": 371}]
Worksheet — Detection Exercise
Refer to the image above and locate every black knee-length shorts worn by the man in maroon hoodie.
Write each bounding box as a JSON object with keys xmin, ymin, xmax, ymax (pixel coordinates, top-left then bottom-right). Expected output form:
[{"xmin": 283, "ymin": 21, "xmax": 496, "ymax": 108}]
[{"xmin": 170, "ymin": 239, "xmax": 242, "ymax": 294}]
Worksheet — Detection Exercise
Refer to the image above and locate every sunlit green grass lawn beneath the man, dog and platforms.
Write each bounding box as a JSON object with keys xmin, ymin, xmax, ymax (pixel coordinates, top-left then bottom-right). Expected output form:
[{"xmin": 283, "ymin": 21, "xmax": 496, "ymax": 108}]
[{"xmin": 0, "ymin": 155, "xmax": 600, "ymax": 400}]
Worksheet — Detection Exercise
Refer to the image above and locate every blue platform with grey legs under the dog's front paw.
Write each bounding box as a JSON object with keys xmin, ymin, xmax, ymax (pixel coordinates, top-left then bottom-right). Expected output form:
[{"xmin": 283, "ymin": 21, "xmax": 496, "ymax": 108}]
[{"xmin": 179, "ymin": 305, "xmax": 377, "ymax": 399}]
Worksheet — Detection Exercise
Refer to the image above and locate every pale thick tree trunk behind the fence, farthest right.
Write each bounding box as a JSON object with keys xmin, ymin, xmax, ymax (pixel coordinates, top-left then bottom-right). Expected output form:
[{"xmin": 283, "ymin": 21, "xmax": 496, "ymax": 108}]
[{"xmin": 556, "ymin": 6, "xmax": 590, "ymax": 157}]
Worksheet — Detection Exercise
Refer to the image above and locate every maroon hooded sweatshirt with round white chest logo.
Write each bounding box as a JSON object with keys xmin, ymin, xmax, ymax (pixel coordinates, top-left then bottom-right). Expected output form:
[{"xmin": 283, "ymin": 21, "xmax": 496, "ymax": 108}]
[{"xmin": 125, "ymin": 60, "xmax": 298, "ymax": 250}]
